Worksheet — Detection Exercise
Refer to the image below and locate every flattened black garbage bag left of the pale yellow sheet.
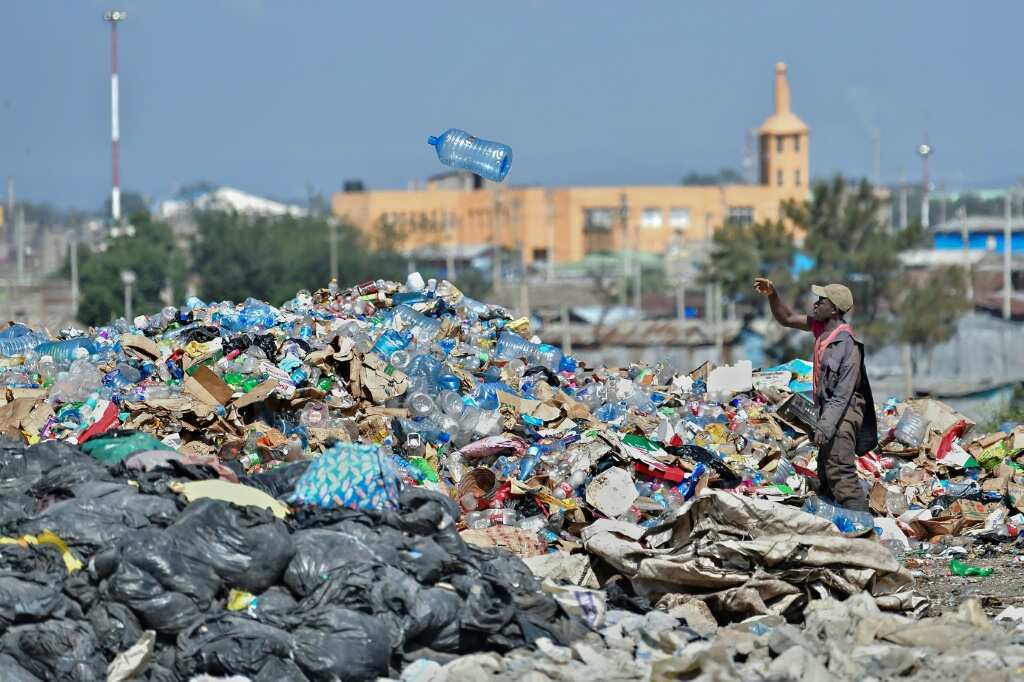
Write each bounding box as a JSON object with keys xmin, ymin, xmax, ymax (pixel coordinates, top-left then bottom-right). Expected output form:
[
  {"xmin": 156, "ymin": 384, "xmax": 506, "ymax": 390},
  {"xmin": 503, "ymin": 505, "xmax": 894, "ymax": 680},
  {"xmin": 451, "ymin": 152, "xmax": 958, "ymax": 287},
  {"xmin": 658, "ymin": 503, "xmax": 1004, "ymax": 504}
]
[{"xmin": 18, "ymin": 482, "xmax": 178, "ymax": 556}]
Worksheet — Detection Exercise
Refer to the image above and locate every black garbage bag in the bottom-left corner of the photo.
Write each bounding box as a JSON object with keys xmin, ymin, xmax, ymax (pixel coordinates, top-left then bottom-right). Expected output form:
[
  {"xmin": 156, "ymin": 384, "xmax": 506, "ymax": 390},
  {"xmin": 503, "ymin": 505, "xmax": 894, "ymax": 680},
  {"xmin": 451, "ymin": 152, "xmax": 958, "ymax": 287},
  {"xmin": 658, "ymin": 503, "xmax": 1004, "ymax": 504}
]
[{"xmin": 0, "ymin": 619, "xmax": 106, "ymax": 682}]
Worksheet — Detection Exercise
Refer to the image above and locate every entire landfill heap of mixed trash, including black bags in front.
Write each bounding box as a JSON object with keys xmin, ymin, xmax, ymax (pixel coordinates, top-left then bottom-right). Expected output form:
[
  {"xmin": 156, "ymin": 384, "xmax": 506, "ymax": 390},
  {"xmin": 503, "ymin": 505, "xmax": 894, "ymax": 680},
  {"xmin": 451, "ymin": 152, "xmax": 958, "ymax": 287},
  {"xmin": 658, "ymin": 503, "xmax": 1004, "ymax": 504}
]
[{"xmin": 0, "ymin": 273, "xmax": 1024, "ymax": 680}]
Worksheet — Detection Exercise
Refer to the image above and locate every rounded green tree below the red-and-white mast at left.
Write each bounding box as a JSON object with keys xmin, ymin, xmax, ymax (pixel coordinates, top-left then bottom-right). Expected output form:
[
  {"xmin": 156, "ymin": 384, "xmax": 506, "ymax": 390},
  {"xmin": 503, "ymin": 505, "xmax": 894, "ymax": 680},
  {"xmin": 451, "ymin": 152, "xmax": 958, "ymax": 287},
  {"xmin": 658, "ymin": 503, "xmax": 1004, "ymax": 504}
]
[{"xmin": 63, "ymin": 211, "xmax": 185, "ymax": 326}]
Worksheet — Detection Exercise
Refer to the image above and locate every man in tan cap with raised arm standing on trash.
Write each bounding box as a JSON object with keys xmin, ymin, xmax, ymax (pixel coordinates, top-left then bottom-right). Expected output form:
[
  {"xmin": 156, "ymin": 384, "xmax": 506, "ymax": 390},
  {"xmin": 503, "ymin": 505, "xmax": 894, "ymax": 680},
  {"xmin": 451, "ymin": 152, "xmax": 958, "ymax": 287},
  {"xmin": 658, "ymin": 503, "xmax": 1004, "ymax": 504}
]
[{"xmin": 754, "ymin": 278, "xmax": 879, "ymax": 511}]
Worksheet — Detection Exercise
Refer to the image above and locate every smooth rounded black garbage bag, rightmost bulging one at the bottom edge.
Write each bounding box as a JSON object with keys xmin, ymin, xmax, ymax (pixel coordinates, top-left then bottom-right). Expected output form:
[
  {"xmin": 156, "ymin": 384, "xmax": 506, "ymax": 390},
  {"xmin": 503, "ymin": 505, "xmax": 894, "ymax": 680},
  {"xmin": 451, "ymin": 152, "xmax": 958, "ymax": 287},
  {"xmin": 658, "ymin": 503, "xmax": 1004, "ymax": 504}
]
[{"xmin": 292, "ymin": 608, "xmax": 391, "ymax": 682}]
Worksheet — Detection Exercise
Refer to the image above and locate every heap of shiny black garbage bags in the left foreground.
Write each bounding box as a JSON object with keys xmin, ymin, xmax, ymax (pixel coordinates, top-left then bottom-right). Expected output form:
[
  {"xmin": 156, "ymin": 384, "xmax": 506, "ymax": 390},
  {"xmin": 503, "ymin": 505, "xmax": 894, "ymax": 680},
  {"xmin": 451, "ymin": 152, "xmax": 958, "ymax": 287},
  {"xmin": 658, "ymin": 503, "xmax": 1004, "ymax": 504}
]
[{"xmin": 0, "ymin": 441, "xmax": 586, "ymax": 682}]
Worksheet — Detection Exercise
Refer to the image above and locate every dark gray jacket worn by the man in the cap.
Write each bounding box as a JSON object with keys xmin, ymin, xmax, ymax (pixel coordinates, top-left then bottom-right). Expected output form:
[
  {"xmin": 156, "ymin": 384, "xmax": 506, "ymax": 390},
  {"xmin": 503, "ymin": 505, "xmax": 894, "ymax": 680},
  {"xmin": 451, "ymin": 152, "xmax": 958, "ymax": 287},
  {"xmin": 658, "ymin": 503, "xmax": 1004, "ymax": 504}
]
[{"xmin": 814, "ymin": 332, "xmax": 879, "ymax": 455}]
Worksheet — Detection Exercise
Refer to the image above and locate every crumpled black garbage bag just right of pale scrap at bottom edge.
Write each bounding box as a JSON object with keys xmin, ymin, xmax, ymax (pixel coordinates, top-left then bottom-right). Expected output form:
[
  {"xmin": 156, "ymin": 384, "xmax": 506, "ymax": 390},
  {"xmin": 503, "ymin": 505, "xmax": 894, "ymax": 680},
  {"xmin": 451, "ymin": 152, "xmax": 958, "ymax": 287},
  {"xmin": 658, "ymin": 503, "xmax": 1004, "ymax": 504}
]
[{"xmin": 175, "ymin": 612, "xmax": 296, "ymax": 679}]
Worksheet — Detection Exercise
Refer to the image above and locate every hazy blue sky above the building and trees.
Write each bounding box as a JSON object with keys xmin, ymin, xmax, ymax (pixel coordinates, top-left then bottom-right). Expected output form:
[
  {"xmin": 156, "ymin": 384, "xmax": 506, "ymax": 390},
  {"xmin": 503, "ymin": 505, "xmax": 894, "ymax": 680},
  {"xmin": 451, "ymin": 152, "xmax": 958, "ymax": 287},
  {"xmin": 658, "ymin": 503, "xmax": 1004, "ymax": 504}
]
[{"xmin": 0, "ymin": 0, "xmax": 1024, "ymax": 208}]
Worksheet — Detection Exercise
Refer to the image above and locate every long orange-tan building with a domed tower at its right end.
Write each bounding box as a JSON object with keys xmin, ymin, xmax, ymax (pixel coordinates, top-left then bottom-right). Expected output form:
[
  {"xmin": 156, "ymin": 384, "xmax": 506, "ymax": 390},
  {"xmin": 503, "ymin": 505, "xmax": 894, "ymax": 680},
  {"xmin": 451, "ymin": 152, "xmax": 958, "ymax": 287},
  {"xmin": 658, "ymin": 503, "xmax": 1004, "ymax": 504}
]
[{"xmin": 332, "ymin": 62, "xmax": 810, "ymax": 263}]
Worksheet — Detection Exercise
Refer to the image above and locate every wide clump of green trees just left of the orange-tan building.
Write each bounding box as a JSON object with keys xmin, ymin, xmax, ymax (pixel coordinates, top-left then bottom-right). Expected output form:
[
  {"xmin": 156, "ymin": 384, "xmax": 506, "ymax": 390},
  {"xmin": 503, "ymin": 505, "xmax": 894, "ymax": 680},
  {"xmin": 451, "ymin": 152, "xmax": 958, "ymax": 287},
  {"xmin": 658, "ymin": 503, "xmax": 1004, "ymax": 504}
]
[{"xmin": 193, "ymin": 211, "xmax": 406, "ymax": 304}]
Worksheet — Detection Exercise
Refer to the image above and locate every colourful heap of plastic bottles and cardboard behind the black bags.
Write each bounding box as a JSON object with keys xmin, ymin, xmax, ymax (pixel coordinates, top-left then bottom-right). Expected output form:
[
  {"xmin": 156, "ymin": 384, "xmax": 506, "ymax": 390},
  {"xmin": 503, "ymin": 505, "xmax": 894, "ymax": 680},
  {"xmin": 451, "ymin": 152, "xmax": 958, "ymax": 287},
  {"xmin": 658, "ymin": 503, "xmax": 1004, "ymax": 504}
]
[{"xmin": 0, "ymin": 273, "xmax": 1015, "ymax": 544}]
